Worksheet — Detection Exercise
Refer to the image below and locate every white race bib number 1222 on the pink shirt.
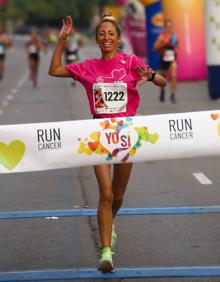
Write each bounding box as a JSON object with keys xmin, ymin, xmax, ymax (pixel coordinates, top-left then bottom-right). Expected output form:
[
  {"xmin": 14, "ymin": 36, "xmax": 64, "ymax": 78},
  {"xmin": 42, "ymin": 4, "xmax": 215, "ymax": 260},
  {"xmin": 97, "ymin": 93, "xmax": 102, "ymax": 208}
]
[{"xmin": 93, "ymin": 82, "xmax": 128, "ymax": 114}]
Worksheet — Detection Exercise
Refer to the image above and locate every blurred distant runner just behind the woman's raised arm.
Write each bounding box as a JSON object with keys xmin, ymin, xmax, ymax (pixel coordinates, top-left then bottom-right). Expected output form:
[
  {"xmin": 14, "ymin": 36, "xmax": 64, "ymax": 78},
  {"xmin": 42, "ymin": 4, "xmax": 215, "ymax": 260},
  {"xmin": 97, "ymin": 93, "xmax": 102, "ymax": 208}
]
[{"xmin": 65, "ymin": 27, "xmax": 83, "ymax": 86}]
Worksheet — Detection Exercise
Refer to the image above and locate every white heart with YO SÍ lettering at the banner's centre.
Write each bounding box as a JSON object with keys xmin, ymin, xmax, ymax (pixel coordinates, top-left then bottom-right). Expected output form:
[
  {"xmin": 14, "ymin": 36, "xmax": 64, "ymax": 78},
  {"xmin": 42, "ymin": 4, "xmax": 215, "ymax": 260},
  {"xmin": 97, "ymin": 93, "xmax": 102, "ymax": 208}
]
[{"xmin": 100, "ymin": 128, "xmax": 138, "ymax": 156}]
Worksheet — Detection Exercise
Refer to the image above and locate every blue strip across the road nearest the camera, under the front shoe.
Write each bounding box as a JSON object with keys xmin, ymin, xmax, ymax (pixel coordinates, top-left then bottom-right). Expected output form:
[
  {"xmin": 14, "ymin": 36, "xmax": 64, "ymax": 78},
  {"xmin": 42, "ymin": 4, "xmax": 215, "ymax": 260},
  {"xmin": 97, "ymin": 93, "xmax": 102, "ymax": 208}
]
[{"xmin": 0, "ymin": 266, "xmax": 220, "ymax": 282}]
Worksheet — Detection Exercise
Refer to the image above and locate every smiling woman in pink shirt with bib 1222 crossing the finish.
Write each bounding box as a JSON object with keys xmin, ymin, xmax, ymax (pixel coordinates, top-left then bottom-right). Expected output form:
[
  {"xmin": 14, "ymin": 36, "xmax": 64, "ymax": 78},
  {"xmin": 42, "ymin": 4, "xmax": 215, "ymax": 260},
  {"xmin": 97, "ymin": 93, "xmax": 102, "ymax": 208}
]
[{"xmin": 49, "ymin": 15, "xmax": 166, "ymax": 273}]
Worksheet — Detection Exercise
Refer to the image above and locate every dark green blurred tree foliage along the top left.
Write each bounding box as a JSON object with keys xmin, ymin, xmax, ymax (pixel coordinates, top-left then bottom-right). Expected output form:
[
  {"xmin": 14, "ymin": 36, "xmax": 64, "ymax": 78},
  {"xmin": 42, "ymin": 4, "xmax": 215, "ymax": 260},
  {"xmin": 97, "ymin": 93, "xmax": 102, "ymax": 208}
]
[{"xmin": 3, "ymin": 0, "xmax": 113, "ymax": 28}]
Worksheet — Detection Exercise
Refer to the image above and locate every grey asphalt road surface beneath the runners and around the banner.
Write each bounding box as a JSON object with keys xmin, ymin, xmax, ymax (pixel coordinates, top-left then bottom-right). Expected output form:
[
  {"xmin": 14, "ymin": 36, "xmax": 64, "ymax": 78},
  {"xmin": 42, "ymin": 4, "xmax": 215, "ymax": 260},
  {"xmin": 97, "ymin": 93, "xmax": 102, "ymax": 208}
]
[{"xmin": 0, "ymin": 37, "xmax": 220, "ymax": 282}]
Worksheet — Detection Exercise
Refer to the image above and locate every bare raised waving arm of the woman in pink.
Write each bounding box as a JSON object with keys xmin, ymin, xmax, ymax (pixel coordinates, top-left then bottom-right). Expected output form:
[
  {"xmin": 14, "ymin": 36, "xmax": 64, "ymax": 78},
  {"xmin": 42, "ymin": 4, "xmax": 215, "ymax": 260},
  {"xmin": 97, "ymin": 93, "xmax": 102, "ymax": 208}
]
[{"xmin": 48, "ymin": 16, "xmax": 73, "ymax": 77}]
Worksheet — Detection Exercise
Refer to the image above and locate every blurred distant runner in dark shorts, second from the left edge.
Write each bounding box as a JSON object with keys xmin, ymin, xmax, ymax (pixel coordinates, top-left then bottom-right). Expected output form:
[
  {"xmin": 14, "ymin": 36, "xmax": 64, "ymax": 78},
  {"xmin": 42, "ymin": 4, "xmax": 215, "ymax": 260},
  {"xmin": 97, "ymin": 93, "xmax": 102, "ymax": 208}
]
[{"xmin": 25, "ymin": 30, "xmax": 46, "ymax": 87}]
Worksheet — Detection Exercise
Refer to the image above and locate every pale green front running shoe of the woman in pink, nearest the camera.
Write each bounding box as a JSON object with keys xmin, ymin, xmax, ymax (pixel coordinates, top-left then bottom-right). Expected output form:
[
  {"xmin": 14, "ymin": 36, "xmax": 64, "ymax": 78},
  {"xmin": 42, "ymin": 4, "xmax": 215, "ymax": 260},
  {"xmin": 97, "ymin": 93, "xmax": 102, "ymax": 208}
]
[{"xmin": 98, "ymin": 247, "xmax": 114, "ymax": 273}]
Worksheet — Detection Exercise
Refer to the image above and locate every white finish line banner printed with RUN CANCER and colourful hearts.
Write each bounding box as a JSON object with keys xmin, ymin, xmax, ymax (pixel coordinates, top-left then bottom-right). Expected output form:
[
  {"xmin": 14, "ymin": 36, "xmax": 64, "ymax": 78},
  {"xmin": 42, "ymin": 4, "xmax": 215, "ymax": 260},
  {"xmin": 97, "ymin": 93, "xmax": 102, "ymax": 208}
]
[{"xmin": 0, "ymin": 111, "xmax": 220, "ymax": 173}]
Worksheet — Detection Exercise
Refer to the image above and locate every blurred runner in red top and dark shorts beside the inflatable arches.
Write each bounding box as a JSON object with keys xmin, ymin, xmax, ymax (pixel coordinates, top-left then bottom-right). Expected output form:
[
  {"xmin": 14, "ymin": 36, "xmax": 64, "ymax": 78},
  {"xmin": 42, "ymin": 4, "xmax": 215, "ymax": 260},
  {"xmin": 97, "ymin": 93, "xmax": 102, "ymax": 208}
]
[{"xmin": 154, "ymin": 19, "xmax": 179, "ymax": 104}]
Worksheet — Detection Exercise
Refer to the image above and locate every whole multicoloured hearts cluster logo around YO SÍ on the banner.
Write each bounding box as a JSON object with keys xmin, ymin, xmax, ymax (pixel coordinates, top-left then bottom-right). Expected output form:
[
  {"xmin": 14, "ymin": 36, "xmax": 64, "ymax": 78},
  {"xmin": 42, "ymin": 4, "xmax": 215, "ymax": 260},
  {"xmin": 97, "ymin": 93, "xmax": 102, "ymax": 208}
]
[{"xmin": 78, "ymin": 118, "xmax": 159, "ymax": 162}]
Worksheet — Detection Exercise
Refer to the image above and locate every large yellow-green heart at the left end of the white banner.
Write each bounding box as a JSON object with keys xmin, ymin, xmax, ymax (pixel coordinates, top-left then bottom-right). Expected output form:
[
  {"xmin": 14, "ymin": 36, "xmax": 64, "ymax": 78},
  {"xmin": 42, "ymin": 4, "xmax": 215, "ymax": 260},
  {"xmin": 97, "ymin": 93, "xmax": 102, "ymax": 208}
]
[{"xmin": 0, "ymin": 140, "xmax": 25, "ymax": 170}]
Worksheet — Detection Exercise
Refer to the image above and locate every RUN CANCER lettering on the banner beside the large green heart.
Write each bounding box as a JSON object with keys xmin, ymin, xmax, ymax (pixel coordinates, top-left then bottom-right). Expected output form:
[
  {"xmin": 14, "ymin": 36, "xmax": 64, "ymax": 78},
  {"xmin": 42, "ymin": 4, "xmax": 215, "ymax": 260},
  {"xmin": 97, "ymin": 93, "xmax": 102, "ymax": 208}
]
[{"xmin": 37, "ymin": 128, "xmax": 62, "ymax": 151}]
